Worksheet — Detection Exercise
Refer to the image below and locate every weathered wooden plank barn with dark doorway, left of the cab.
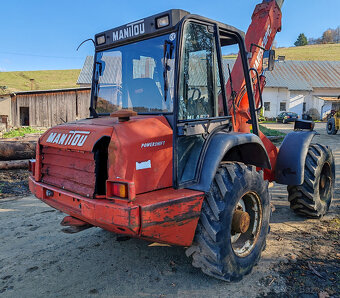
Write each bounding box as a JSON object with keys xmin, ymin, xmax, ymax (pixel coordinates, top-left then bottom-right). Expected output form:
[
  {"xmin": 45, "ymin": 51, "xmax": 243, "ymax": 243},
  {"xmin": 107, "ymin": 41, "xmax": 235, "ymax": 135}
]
[{"xmin": 0, "ymin": 88, "xmax": 91, "ymax": 127}]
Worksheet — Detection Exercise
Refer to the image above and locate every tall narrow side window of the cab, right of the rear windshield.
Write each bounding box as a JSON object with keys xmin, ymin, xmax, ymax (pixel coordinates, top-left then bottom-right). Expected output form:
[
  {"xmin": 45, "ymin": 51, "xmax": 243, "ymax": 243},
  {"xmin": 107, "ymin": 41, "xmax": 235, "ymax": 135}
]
[{"xmin": 178, "ymin": 22, "xmax": 218, "ymax": 120}]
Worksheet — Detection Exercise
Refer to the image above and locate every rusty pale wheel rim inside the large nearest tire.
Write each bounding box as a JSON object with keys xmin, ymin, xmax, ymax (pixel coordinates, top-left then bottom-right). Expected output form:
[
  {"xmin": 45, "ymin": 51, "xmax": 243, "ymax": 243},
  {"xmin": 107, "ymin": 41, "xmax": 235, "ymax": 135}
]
[{"xmin": 231, "ymin": 192, "xmax": 262, "ymax": 257}]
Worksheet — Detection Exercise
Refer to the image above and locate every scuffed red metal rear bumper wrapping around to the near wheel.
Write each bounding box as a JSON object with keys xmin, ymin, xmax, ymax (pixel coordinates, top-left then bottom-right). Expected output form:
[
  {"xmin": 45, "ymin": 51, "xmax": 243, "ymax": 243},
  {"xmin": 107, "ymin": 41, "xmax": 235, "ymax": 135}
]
[{"xmin": 29, "ymin": 177, "xmax": 204, "ymax": 246}]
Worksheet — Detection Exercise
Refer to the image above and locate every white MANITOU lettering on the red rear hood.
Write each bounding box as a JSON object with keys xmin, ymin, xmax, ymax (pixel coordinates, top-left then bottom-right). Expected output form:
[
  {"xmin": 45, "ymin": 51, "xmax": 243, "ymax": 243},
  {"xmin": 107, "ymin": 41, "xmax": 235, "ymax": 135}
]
[{"xmin": 46, "ymin": 130, "xmax": 90, "ymax": 147}]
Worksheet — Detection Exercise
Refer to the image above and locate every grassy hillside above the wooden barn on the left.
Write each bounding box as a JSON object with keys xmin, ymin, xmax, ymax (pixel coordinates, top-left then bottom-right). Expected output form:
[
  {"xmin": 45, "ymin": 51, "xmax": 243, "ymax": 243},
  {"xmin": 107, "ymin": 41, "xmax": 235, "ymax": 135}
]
[{"xmin": 0, "ymin": 69, "xmax": 80, "ymax": 93}]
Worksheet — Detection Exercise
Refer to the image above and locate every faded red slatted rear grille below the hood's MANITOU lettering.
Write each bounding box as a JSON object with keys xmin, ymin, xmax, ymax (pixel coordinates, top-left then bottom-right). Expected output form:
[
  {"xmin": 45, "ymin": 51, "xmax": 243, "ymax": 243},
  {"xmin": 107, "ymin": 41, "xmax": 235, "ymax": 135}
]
[{"xmin": 41, "ymin": 146, "xmax": 96, "ymax": 197}]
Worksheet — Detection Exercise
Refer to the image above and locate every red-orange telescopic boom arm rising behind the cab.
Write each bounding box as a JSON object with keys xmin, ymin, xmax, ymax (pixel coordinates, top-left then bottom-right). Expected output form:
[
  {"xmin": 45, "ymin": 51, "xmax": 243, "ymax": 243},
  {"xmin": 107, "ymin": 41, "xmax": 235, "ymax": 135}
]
[{"xmin": 226, "ymin": 0, "xmax": 283, "ymax": 180}]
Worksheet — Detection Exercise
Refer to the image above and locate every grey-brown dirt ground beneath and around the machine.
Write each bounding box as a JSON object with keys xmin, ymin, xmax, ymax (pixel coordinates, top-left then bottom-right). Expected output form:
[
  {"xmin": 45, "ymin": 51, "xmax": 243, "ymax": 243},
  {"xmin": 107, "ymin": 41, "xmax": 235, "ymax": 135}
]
[{"xmin": 0, "ymin": 123, "xmax": 340, "ymax": 297}]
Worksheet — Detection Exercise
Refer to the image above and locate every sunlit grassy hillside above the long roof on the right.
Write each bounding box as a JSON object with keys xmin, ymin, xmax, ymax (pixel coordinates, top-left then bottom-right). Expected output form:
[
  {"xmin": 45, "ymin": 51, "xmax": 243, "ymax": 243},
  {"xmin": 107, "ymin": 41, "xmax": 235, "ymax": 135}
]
[{"xmin": 275, "ymin": 43, "xmax": 340, "ymax": 61}]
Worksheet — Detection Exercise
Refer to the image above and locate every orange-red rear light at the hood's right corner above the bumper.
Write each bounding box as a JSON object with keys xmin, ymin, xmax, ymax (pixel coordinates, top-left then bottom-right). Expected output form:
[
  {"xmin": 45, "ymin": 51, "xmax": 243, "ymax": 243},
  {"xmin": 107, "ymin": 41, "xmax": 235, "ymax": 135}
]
[{"xmin": 106, "ymin": 180, "xmax": 136, "ymax": 201}]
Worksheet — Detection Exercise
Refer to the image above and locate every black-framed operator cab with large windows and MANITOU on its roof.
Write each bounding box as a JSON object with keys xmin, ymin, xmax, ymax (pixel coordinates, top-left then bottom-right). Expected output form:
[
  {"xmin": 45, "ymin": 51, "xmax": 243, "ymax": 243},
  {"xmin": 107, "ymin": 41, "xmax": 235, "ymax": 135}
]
[{"xmin": 91, "ymin": 9, "xmax": 258, "ymax": 187}]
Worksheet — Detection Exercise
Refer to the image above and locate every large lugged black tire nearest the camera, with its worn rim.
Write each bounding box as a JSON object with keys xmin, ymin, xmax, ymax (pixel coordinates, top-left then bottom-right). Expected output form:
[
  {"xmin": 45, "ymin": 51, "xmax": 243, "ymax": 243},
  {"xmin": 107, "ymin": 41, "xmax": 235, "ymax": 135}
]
[{"xmin": 186, "ymin": 163, "xmax": 270, "ymax": 281}]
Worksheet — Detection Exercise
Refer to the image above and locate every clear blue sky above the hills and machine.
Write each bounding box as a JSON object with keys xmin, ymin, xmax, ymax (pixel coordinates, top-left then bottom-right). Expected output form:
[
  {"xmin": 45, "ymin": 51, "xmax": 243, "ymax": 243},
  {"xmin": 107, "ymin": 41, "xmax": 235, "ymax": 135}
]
[{"xmin": 0, "ymin": 0, "xmax": 340, "ymax": 71}]
